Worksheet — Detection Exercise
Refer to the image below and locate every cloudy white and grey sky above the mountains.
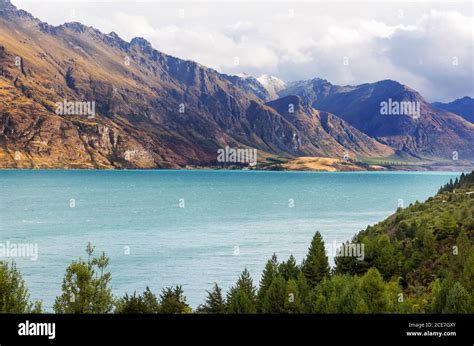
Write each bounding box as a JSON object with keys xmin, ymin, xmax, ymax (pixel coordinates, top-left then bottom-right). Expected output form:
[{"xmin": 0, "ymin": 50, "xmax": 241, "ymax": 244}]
[{"xmin": 12, "ymin": 0, "xmax": 474, "ymax": 101}]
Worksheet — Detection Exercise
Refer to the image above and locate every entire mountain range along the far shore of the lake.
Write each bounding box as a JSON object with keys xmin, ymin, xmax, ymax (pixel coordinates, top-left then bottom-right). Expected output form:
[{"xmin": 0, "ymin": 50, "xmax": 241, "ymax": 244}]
[{"xmin": 0, "ymin": 0, "xmax": 474, "ymax": 168}]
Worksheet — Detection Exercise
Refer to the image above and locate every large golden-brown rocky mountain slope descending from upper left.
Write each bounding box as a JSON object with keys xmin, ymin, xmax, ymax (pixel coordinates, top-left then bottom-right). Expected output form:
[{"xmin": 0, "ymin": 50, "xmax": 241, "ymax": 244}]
[{"xmin": 0, "ymin": 0, "xmax": 396, "ymax": 168}]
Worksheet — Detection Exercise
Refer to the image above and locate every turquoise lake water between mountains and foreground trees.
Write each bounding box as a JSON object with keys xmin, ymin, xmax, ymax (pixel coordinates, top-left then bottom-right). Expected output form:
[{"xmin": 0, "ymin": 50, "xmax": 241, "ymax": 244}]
[{"xmin": 0, "ymin": 170, "xmax": 458, "ymax": 310}]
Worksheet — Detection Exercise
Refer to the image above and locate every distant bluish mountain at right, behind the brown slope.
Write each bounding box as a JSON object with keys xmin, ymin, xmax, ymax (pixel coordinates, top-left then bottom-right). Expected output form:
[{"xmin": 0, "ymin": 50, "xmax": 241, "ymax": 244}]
[{"xmin": 279, "ymin": 78, "xmax": 474, "ymax": 159}]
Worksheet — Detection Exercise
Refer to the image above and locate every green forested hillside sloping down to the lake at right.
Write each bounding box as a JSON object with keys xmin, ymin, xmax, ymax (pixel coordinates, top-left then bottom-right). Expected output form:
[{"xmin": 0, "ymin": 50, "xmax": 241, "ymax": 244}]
[{"xmin": 335, "ymin": 173, "xmax": 474, "ymax": 312}]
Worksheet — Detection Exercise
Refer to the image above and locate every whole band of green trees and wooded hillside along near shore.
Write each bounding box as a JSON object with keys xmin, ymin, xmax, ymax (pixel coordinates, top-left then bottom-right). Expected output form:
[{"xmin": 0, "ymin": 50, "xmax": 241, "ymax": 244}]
[{"xmin": 0, "ymin": 173, "xmax": 474, "ymax": 314}]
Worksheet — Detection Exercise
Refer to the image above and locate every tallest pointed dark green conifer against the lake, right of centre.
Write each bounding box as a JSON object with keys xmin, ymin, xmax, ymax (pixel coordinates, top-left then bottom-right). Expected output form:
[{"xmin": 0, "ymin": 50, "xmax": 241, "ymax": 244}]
[{"xmin": 303, "ymin": 231, "xmax": 329, "ymax": 287}]
